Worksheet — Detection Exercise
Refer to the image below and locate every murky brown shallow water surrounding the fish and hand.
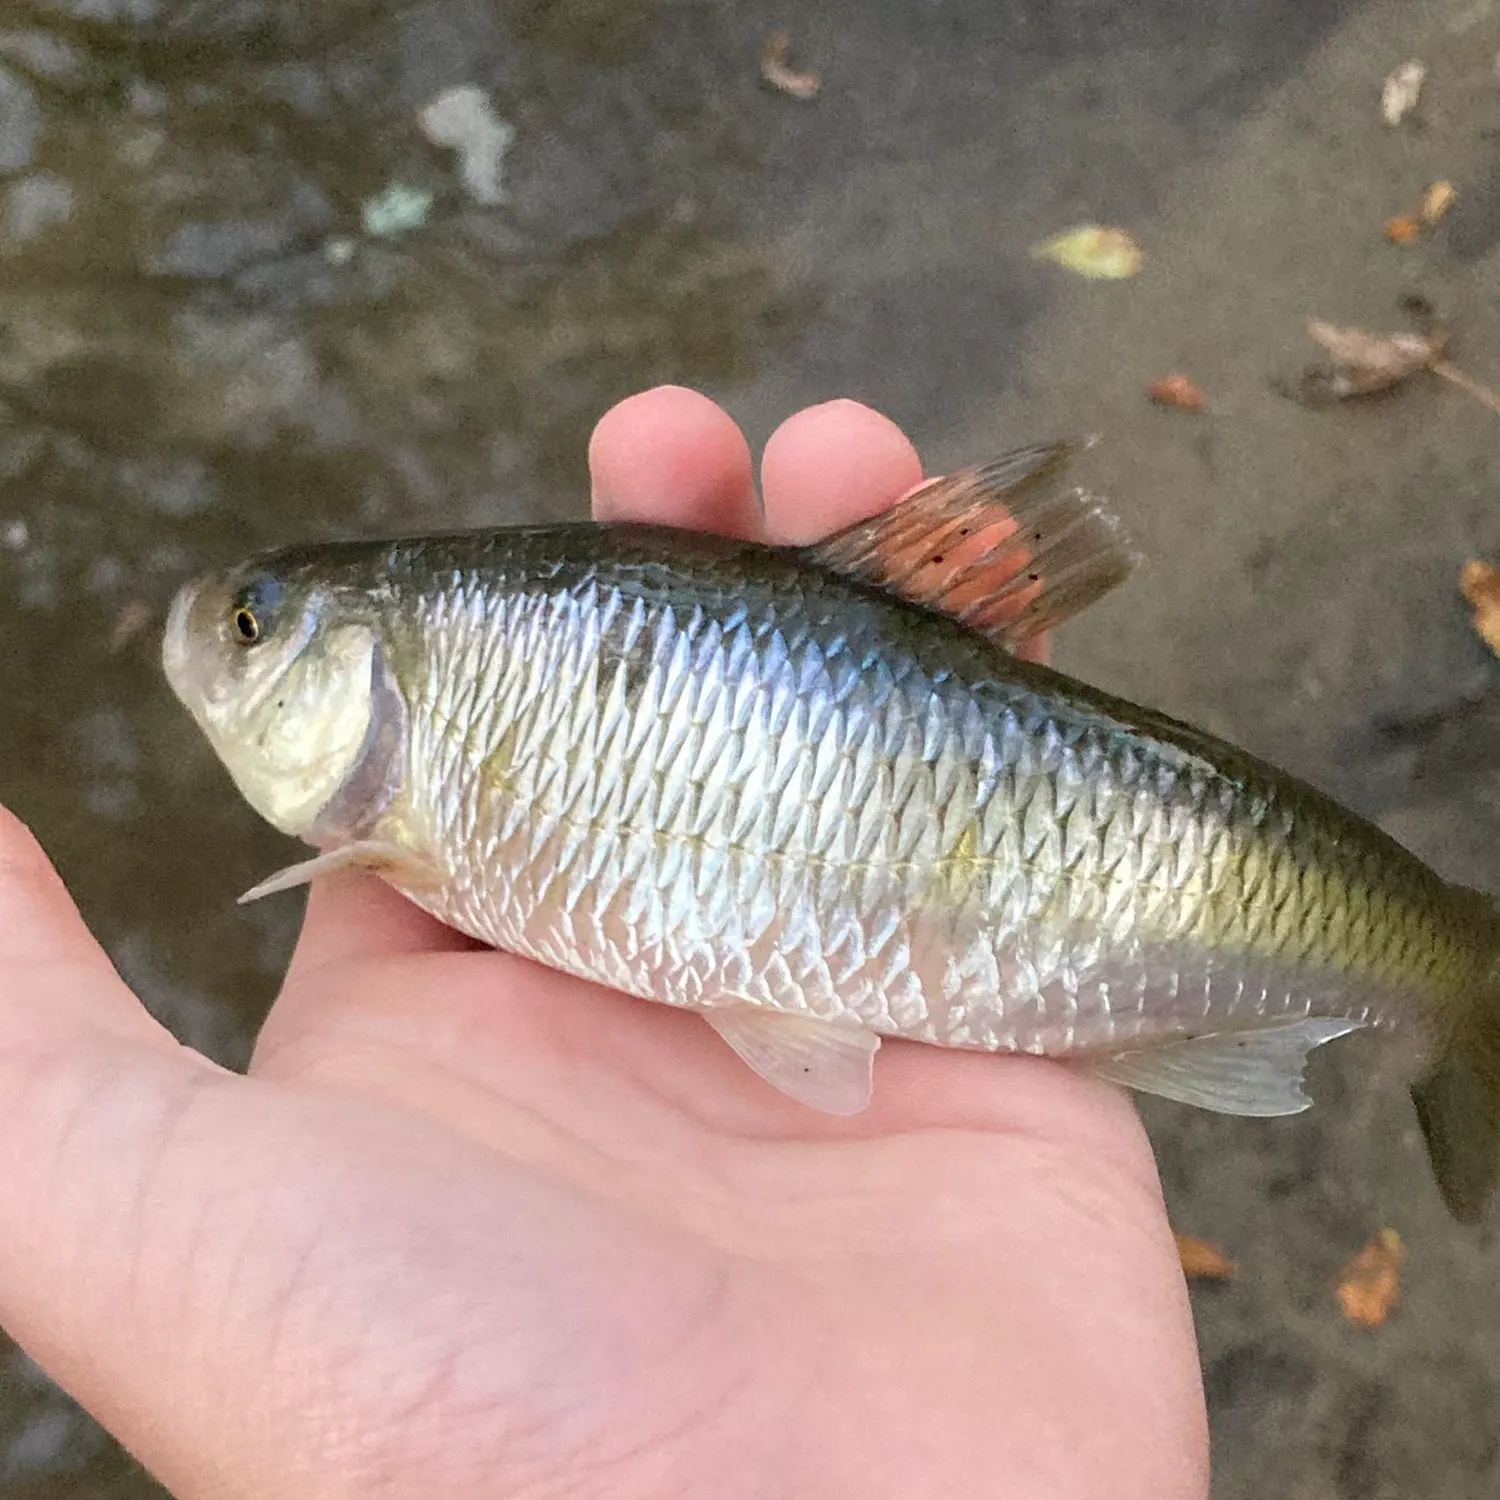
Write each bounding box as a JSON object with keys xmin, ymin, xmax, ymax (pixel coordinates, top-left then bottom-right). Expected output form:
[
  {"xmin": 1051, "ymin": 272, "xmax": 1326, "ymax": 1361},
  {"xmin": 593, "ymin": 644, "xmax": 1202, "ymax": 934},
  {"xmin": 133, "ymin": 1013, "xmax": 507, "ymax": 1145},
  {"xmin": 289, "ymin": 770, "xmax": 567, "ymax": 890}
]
[{"xmin": 0, "ymin": 0, "xmax": 1500, "ymax": 1500}]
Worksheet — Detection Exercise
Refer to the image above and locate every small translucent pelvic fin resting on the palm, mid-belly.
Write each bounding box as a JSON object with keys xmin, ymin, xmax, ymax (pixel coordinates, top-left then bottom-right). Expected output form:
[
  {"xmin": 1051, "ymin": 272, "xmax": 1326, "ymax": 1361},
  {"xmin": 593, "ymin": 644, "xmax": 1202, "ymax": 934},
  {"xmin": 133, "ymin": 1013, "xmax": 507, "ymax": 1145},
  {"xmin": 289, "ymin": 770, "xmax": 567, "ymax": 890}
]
[{"xmin": 705, "ymin": 1005, "xmax": 881, "ymax": 1115}]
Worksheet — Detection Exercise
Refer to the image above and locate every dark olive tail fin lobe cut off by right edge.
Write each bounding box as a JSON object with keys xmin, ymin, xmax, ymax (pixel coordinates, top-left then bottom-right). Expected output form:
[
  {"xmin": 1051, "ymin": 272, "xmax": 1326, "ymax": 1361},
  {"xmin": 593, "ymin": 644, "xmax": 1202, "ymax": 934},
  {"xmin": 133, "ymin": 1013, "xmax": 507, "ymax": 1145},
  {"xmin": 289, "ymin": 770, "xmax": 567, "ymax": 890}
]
[{"xmin": 1412, "ymin": 974, "xmax": 1500, "ymax": 1224}]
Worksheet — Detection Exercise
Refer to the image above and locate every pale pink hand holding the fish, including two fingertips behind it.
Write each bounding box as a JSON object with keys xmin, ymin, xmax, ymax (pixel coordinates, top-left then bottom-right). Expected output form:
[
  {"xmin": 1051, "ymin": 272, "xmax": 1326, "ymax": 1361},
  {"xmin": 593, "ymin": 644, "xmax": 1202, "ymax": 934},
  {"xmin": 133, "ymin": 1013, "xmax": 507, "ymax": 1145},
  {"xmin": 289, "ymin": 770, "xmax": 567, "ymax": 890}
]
[{"xmin": 0, "ymin": 389, "xmax": 1208, "ymax": 1500}]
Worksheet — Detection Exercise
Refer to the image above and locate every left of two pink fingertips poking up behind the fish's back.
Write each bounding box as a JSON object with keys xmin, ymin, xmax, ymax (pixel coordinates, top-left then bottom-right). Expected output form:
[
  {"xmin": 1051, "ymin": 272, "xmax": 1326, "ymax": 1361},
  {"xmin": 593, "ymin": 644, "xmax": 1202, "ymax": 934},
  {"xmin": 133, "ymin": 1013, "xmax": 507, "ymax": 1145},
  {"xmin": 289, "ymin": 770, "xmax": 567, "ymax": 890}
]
[{"xmin": 588, "ymin": 386, "xmax": 761, "ymax": 537}]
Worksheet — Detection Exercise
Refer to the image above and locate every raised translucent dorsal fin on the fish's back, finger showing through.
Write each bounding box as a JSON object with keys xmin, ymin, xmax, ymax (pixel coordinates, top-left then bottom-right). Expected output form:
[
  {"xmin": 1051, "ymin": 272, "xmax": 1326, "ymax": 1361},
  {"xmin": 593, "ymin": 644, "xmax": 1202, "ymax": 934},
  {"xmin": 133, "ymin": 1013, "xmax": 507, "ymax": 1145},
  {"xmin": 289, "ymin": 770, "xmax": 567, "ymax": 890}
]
[{"xmin": 803, "ymin": 443, "xmax": 1137, "ymax": 651}]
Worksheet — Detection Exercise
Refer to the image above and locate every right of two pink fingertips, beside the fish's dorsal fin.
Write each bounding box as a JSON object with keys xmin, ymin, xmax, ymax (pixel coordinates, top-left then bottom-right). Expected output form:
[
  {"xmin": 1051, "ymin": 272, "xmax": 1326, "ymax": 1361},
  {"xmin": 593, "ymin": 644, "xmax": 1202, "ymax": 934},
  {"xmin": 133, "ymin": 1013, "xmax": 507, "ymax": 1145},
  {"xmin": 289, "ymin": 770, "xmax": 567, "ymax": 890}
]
[{"xmin": 761, "ymin": 401, "xmax": 923, "ymax": 542}]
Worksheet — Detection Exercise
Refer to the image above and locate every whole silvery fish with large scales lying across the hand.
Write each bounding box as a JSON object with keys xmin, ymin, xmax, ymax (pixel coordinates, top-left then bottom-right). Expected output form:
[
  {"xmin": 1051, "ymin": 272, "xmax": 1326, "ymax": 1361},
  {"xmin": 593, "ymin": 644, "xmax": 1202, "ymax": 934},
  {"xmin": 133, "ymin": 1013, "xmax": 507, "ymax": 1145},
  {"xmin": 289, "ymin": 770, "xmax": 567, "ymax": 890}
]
[{"xmin": 162, "ymin": 441, "xmax": 1500, "ymax": 1223}]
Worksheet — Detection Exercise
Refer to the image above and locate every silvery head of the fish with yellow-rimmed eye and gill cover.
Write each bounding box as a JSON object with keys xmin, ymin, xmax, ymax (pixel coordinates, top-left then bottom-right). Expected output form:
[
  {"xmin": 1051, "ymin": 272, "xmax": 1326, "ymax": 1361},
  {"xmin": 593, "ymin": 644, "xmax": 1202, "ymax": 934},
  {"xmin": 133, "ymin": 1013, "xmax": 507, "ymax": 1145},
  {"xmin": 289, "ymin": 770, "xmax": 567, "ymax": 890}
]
[{"xmin": 162, "ymin": 560, "xmax": 404, "ymax": 843}]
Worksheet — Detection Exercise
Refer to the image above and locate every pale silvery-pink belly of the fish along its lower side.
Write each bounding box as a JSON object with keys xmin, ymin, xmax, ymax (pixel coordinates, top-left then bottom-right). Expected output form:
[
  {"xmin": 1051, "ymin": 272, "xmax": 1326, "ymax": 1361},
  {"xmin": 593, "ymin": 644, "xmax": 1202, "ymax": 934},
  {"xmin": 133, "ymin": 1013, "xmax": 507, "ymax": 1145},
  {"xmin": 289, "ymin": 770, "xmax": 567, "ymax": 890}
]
[{"xmin": 416, "ymin": 810, "xmax": 1401, "ymax": 1056}]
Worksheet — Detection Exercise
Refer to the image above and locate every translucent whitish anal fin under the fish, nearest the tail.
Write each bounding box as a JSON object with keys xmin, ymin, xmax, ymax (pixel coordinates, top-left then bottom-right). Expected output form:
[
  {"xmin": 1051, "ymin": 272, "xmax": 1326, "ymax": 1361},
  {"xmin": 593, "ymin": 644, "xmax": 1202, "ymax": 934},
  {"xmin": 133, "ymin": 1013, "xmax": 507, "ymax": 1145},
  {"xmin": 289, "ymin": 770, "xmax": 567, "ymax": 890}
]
[{"xmin": 1094, "ymin": 1016, "xmax": 1364, "ymax": 1116}]
